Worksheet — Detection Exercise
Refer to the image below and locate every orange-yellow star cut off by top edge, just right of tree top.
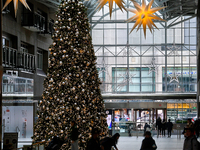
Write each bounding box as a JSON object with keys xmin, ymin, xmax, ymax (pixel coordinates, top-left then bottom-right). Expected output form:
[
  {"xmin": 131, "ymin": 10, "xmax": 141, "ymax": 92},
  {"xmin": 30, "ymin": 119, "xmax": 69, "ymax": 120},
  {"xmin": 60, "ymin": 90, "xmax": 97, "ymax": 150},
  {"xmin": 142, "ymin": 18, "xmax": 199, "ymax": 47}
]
[{"xmin": 96, "ymin": 0, "xmax": 126, "ymax": 18}]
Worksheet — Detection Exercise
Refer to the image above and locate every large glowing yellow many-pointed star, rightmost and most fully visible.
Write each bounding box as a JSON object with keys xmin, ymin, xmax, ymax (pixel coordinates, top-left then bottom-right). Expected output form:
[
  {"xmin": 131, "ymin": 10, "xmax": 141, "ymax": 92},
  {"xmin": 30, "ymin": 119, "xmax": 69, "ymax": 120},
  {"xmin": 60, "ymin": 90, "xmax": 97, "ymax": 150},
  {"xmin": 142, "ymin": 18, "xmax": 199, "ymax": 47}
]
[{"xmin": 126, "ymin": 0, "xmax": 166, "ymax": 38}]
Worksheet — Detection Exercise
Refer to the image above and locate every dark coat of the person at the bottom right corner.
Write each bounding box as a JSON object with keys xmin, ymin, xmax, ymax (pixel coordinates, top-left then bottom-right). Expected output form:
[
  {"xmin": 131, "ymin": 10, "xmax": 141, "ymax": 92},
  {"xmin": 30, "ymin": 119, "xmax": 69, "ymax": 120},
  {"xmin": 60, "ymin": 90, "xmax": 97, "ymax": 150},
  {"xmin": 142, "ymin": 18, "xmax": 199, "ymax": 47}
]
[{"xmin": 183, "ymin": 136, "xmax": 199, "ymax": 150}]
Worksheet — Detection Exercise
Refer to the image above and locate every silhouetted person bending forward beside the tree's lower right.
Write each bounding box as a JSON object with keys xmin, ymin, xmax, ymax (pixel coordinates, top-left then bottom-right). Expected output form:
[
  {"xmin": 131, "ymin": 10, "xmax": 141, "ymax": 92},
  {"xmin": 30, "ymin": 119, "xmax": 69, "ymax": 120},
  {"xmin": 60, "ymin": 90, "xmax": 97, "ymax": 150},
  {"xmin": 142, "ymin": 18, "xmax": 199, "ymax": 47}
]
[{"xmin": 101, "ymin": 133, "xmax": 120, "ymax": 150}]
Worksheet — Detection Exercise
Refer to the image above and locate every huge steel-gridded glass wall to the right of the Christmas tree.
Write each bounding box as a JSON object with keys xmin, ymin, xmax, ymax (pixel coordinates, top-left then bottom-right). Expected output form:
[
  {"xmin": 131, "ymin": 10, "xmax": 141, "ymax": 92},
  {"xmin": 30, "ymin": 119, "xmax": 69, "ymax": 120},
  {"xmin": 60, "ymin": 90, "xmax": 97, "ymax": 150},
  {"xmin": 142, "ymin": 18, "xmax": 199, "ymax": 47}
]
[{"xmin": 90, "ymin": 0, "xmax": 197, "ymax": 93}]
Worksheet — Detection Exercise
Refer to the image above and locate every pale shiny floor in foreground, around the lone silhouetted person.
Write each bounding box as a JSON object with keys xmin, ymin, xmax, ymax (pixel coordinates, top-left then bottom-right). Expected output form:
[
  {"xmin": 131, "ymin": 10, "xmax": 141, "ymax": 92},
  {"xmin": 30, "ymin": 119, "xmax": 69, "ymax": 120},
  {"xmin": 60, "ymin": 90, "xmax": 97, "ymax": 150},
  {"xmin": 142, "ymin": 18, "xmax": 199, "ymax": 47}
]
[{"xmin": 117, "ymin": 135, "xmax": 184, "ymax": 150}]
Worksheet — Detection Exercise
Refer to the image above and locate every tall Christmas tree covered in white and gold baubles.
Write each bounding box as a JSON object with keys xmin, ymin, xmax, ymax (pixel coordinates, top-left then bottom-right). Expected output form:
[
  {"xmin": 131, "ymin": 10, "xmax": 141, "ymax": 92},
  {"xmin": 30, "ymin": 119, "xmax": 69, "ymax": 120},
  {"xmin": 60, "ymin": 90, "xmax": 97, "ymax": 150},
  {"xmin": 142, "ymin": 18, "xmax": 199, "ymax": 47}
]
[{"xmin": 33, "ymin": 0, "xmax": 107, "ymax": 150}]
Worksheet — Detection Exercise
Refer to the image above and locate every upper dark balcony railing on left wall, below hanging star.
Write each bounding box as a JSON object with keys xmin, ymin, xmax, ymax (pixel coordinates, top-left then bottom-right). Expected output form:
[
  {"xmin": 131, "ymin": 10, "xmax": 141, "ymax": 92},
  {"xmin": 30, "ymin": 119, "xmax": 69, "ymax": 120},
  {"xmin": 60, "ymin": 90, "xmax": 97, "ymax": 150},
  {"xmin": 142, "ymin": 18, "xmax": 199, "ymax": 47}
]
[{"xmin": 22, "ymin": 12, "xmax": 45, "ymax": 32}]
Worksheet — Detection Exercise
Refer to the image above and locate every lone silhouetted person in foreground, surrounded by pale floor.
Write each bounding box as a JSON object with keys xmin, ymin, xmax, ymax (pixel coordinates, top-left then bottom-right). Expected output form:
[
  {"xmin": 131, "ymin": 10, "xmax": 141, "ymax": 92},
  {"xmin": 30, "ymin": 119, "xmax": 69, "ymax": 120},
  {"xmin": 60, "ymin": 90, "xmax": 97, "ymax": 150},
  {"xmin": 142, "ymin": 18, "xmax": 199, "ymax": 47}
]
[{"xmin": 140, "ymin": 131, "xmax": 157, "ymax": 150}]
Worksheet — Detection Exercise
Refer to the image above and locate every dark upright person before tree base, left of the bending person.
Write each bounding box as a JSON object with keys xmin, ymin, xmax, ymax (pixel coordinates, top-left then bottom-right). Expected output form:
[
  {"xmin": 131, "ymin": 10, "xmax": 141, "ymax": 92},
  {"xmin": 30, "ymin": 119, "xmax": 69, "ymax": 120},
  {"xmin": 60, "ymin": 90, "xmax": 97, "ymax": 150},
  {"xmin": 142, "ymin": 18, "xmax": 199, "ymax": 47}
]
[{"xmin": 86, "ymin": 128, "xmax": 101, "ymax": 150}]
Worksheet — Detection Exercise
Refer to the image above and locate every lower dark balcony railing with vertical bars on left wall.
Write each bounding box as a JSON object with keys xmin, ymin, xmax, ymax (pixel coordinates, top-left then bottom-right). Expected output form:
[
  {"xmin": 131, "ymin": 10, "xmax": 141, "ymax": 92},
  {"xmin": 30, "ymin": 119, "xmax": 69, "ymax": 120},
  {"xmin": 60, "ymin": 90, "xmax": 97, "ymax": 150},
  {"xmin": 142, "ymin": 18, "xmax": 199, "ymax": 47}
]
[{"xmin": 3, "ymin": 46, "xmax": 36, "ymax": 72}]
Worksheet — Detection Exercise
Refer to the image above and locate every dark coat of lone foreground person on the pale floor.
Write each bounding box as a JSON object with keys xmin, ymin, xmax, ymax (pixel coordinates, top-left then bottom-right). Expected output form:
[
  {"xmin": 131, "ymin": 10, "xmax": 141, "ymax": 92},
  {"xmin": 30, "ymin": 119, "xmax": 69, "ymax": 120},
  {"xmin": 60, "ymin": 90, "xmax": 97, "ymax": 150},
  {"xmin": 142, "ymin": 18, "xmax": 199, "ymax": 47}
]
[{"xmin": 140, "ymin": 137, "xmax": 157, "ymax": 150}]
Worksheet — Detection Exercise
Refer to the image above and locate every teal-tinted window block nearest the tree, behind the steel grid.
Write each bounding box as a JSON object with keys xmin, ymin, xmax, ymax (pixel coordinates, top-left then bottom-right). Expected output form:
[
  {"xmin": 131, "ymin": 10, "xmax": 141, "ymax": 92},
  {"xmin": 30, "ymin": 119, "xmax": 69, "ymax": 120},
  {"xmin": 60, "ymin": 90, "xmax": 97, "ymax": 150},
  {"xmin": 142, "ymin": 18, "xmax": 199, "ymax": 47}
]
[{"xmin": 112, "ymin": 67, "xmax": 155, "ymax": 92}]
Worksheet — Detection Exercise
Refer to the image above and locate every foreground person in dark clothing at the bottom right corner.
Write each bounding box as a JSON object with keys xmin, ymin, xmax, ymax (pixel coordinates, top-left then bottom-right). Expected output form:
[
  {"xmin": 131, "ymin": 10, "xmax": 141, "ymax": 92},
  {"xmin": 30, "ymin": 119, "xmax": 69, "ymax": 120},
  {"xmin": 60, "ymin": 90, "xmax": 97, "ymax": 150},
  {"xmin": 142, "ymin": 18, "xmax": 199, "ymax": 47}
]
[{"xmin": 183, "ymin": 128, "xmax": 199, "ymax": 150}]
